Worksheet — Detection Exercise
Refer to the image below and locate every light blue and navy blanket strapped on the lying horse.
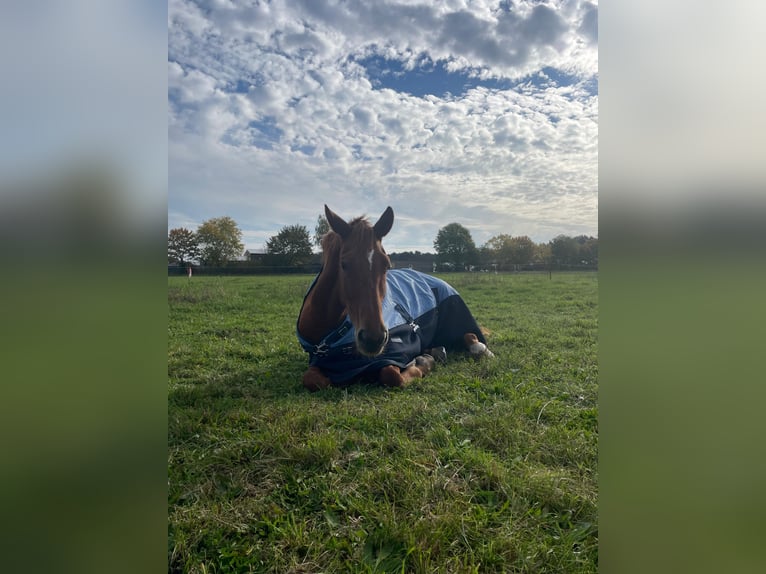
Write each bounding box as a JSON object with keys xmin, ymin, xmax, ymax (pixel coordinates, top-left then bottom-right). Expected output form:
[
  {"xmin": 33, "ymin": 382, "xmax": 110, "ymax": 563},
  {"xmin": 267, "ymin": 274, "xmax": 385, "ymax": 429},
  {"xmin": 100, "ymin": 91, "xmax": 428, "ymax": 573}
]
[{"xmin": 296, "ymin": 269, "xmax": 486, "ymax": 386}]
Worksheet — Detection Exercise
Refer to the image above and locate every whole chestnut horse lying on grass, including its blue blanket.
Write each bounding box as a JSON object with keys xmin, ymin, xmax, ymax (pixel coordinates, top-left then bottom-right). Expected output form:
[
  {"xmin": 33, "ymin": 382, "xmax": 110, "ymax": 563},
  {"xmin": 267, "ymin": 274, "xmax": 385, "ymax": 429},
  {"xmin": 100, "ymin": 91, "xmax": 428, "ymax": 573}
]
[{"xmin": 296, "ymin": 205, "xmax": 493, "ymax": 392}]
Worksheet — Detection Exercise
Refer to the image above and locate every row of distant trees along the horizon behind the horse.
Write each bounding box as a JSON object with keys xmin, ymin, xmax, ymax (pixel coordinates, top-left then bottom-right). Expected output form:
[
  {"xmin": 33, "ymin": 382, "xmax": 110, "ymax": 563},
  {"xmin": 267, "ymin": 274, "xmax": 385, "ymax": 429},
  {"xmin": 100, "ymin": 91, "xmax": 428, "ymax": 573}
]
[{"xmin": 168, "ymin": 215, "xmax": 598, "ymax": 271}]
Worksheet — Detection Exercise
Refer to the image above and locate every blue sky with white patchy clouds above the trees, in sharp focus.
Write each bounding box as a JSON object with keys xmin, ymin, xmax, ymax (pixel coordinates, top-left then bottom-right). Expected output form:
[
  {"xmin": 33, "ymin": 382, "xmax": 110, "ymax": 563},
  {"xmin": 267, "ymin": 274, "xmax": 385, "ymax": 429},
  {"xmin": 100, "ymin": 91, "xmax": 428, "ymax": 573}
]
[{"xmin": 168, "ymin": 0, "xmax": 598, "ymax": 252}]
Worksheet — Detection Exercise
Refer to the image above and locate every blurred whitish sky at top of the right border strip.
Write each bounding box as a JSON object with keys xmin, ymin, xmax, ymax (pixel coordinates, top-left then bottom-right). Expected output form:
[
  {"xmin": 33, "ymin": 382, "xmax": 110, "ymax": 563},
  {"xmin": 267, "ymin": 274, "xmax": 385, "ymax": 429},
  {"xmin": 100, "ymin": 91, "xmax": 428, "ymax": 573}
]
[{"xmin": 599, "ymin": 0, "xmax": 766, "ymax": 209}]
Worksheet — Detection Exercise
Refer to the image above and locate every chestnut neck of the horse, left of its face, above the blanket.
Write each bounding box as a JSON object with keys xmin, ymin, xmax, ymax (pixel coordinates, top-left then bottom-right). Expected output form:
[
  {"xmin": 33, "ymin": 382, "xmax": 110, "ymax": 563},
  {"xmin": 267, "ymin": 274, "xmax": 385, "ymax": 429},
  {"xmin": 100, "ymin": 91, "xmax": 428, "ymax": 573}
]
[{"xmin": 298, "ymin": 246, "xmax": 346, "ymax": 343}]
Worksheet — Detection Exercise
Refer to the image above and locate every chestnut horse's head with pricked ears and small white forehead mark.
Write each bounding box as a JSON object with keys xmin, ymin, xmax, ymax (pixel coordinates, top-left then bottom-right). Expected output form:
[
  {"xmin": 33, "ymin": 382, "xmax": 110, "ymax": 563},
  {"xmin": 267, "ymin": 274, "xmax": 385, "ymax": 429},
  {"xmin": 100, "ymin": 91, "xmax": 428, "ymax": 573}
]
[{"xmin": 324, "ymin": 205, "xmax": 394, "ymax": 357}]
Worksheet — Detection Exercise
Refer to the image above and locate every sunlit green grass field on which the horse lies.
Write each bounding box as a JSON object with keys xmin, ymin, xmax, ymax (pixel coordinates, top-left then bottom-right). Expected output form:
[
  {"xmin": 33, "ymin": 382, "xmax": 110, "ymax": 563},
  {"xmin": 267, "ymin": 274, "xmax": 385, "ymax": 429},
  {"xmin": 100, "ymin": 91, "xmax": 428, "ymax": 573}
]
[{"xmin": 168, "ymin": 273, "xmax": 598, "ymax": 573}]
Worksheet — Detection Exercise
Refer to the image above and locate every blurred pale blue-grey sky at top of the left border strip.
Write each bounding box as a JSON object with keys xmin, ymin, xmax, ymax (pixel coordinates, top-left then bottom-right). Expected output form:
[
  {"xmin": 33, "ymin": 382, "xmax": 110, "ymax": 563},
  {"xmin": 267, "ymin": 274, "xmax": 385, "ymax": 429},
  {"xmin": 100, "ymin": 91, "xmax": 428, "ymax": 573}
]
[{"xmin": 0, "ymin": 0, "xmax": 167, "ymax": 233}]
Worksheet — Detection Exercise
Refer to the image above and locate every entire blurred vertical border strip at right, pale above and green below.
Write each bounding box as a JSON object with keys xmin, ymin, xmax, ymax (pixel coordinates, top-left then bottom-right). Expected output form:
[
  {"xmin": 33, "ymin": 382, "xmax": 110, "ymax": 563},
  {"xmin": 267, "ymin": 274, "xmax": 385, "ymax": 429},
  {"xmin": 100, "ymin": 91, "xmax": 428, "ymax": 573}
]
[{"xmin": 599, "ymin": 0, "xmax": 766, "ymax": 573}]
